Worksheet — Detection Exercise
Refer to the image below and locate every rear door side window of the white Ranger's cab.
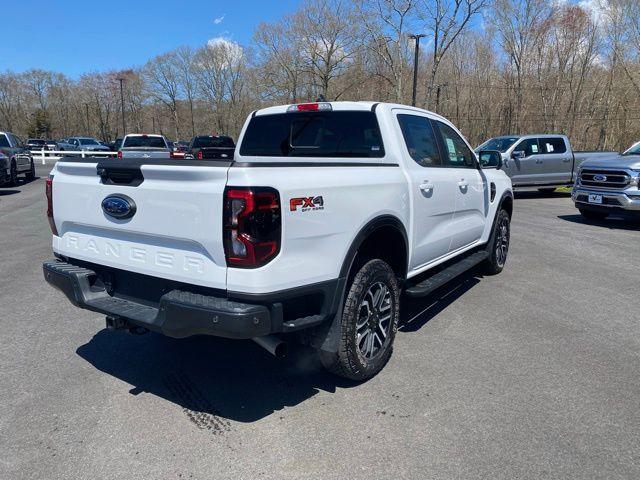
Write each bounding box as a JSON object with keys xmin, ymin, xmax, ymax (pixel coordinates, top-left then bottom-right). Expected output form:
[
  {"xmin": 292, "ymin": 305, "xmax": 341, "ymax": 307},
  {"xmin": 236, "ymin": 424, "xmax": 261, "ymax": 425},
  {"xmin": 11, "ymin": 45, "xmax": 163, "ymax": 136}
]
[{"xmin": 398, "ymin": 114, "xmax": 442, "ymax": 167}]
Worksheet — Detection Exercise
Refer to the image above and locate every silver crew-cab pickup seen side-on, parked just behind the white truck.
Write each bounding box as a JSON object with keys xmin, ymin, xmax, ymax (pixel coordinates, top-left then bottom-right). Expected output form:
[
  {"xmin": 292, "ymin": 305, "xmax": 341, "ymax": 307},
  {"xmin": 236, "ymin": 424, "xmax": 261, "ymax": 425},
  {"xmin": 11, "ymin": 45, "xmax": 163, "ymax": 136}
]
[{"xmin": 477, "ymin": 135, "xmax": 618, "ymax": 192}]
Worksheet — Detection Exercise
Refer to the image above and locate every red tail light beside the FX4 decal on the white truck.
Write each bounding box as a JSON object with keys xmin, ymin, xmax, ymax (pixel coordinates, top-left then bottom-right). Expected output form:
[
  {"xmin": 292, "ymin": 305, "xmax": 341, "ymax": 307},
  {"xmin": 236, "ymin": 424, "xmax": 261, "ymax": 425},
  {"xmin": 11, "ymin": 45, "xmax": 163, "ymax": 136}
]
[{"xmin": 223, "ymin": 187, "xmax": 281, "ymax": 268}]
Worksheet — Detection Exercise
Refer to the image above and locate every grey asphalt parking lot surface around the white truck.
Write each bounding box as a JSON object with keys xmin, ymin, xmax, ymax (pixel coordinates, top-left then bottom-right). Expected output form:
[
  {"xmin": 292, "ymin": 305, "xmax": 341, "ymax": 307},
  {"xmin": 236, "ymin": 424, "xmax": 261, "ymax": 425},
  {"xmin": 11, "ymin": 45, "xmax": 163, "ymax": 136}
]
[{"xmin": 0, "ymin": 165, "xmax": 640, "ymax": 479}]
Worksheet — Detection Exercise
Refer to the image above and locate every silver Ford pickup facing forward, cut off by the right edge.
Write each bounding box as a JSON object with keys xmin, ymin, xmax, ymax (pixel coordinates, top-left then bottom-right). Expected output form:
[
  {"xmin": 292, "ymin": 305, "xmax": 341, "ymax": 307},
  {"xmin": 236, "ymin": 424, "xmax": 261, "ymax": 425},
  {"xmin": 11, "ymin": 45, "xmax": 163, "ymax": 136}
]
[{"xmin": 571, "ymin": 143, "xmax": 640, "ymax": 220}]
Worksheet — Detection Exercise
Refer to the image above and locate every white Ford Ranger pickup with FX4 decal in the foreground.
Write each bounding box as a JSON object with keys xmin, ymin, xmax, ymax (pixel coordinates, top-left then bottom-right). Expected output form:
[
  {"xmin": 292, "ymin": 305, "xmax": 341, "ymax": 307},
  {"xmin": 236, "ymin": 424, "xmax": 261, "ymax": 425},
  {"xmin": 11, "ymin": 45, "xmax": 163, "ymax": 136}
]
[{"xmin": 43, "ymin": 102, "xmax": 513, "ymax": 380}]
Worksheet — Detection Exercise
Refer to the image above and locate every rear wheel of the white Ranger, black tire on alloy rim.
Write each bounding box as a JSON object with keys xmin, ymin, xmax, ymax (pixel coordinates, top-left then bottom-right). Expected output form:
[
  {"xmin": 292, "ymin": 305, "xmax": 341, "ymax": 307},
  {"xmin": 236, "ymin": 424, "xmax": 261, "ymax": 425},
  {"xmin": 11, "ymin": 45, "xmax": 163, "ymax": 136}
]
[{"xmin": 320, "ymin": 259, "xmax": 400, "ymax": 381}]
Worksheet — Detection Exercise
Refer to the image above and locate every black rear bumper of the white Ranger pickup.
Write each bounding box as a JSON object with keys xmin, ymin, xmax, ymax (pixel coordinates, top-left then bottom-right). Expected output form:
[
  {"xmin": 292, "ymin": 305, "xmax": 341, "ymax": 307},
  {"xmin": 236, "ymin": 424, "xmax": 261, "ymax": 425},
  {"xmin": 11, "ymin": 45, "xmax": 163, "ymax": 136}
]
[{"xmin": 42, "ymin": 260, "xmax": 343, "ymax": 339}]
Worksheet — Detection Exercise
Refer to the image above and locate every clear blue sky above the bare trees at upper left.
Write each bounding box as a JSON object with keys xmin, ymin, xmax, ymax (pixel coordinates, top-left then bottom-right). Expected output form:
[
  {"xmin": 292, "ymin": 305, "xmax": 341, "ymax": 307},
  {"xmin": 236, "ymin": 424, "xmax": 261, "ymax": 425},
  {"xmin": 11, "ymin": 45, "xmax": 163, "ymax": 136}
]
[{"xmin": 0, "ymin": 0, "xmax": 300, "ymax": 78}]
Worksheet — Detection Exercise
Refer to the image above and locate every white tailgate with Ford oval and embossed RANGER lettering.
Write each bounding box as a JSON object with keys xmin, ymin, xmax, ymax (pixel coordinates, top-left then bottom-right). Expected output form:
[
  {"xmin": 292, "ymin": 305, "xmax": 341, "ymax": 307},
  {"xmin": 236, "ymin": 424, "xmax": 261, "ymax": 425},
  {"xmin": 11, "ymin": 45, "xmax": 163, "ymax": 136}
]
[{"xmin": 53, "ymin": 160, "xmax": 229, "ymax": 288}]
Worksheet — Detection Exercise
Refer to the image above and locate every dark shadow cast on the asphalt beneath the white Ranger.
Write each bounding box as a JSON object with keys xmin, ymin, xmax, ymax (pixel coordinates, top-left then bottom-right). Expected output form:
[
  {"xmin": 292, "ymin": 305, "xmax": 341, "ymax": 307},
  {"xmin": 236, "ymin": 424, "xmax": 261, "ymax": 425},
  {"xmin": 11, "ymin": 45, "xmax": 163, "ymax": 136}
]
[{"xmin": 76, "ymin": 273, "xmax": 479, "ymax": 424}]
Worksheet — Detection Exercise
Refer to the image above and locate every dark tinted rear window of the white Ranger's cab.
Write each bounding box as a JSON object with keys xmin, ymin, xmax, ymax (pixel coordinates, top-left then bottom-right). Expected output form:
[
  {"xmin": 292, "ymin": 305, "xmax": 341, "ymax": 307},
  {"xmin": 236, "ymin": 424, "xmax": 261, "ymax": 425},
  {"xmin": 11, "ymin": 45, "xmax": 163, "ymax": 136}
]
[{"xmin": 240, "ymin": 111, "xmax": 384, "ymax": 158}]
